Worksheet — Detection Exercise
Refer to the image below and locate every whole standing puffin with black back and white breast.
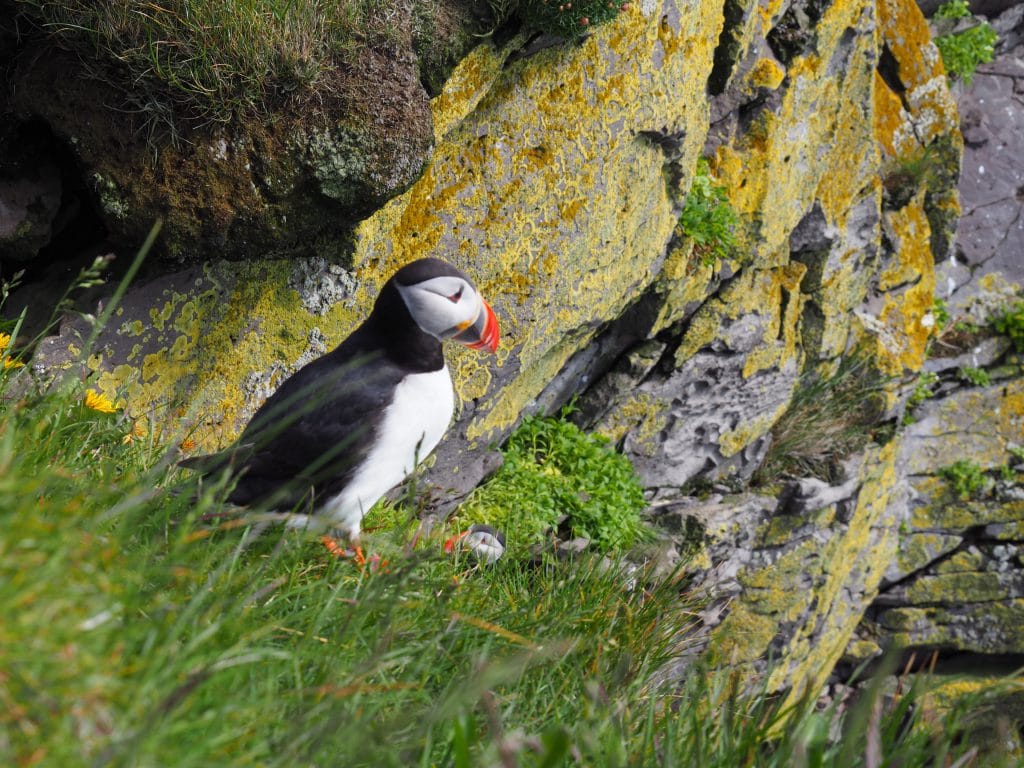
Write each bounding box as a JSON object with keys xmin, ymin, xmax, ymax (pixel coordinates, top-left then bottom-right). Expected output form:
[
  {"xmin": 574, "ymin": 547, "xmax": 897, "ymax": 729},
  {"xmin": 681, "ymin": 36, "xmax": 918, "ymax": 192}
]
[{"xmin": 181, "ymin": 258, "xmax": 499, "ymax": 544}]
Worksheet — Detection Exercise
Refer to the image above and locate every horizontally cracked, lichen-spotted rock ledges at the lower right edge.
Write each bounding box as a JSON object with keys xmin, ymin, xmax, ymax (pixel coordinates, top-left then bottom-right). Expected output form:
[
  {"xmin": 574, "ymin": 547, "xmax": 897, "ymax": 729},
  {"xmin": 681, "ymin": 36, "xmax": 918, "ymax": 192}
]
[{"xmin": 863, "ymin": 378, "xmax": 1024, "ymax": 654}]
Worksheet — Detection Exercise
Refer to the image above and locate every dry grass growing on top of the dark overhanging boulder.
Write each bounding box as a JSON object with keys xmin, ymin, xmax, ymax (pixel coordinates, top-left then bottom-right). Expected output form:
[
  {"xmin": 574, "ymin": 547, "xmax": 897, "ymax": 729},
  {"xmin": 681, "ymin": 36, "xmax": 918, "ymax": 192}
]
[{"xmin": 14, "ymin": 0, "xmax": 456, "ymax": 128}]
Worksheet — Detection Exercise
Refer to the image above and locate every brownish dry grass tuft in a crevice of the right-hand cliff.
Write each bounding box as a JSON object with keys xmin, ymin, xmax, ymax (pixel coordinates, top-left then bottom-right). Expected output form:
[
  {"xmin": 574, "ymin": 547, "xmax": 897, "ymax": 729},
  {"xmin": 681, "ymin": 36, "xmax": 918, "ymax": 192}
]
[{"xmin": 754, "ymin": 357, "xmax": 887, "ymax": 483}]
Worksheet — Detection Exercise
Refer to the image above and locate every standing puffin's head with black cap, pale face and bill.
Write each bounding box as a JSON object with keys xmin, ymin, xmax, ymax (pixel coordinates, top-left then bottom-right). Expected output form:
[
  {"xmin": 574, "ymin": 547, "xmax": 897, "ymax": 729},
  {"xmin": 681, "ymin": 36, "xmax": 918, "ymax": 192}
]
[{"xmin": 388, "ymin": 259, "xmax": 499, "ymax": 352}]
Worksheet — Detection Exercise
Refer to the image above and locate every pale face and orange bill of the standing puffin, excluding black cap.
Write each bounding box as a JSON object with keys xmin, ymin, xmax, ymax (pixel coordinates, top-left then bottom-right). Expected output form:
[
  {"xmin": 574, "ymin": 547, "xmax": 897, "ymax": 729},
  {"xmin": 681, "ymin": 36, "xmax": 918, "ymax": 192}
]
[{"xmin": 396, "ymin": 274, "xmax": 498, "ymax": 352}]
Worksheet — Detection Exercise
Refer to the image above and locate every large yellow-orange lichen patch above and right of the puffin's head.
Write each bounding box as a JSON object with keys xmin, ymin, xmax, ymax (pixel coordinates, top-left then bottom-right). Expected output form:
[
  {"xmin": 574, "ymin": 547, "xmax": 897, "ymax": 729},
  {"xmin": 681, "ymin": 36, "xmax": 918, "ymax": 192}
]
[{"xmin": 354, "ymin": 0, "xmax": 722, "ymax": 438}]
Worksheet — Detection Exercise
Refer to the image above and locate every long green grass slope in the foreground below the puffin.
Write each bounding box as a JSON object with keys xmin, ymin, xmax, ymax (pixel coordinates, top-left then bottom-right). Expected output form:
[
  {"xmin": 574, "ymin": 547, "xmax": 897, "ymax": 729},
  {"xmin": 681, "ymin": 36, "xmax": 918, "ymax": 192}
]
[{"xmin": 0, "ymin": 266, "xmax": 1009, "ymax": 768}]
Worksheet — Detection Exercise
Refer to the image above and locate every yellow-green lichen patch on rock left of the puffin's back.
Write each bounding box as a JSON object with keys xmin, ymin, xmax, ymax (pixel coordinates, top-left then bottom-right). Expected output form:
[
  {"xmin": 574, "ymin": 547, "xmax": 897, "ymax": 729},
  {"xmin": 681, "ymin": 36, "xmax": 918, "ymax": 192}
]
[{"xmin": 87, "ymin": 262, "xmax": 365, "ymax": 450}]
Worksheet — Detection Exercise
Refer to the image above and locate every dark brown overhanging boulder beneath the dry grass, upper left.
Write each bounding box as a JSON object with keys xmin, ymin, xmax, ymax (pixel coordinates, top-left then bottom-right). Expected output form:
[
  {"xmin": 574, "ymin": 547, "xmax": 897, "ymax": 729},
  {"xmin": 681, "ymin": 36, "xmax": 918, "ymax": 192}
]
[{"xmin": 0, "ymin": 0, "xmax": 479, "ymax": 263}]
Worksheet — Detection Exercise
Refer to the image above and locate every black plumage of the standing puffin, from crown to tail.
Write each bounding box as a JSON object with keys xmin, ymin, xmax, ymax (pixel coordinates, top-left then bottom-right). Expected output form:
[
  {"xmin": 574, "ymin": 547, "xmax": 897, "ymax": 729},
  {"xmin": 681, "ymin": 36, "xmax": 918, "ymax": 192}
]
[{"xmin": 182, "ymin": 268, "xmax": 448, "ymax": 514}]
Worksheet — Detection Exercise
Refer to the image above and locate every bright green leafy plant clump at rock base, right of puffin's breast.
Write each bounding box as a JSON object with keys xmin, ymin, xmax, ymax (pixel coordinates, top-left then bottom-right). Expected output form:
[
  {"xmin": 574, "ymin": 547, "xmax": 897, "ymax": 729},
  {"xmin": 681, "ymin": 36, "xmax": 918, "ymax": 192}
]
[{"xmin": 458, "ymin": 417, "xmax": 646, "ymax": 552}]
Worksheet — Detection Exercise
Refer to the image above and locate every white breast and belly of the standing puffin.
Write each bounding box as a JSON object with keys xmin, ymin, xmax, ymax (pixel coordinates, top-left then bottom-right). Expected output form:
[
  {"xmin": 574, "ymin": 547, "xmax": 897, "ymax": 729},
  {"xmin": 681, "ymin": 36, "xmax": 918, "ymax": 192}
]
[{"xmin": 322, "ymin": 366, "xmax": 455, "ymax": 535}]
